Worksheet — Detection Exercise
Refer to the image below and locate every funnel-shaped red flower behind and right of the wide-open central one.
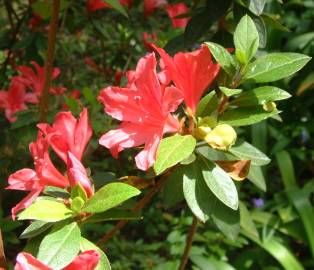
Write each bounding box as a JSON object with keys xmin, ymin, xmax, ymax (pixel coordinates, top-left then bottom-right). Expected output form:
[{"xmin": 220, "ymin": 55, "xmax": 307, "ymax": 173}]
[{"xmin": 154, "ymin": 46, "xmax": 219, "ymax": 113}]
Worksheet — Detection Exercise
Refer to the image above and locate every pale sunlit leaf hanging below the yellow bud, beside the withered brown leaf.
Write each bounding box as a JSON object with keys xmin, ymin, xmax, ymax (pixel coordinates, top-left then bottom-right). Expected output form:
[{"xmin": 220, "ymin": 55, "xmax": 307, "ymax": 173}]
[{"xmin": 198, "ymin": 158, "xmax": 239, "ymax": 210}]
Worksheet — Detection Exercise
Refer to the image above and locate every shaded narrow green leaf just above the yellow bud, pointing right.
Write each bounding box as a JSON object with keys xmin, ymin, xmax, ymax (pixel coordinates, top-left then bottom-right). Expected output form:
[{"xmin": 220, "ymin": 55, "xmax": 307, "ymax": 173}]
[{"xmin": 219, "ymin": 106, "xmax": 280, "ymax": 126}]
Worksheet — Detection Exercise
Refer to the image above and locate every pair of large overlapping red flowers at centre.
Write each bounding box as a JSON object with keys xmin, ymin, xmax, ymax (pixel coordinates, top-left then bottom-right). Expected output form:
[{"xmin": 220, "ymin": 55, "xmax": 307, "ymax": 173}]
[{"xmin": 98, "ymin": 46, "xmax": 219, "ymax": 170}]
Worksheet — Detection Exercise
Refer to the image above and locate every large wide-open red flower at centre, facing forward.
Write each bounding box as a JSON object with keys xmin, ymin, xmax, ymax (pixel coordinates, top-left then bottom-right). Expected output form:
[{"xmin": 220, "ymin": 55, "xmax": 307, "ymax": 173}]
[{"xmin": 98, "ymin": 53, "xmax": 182, "ymax": 170}]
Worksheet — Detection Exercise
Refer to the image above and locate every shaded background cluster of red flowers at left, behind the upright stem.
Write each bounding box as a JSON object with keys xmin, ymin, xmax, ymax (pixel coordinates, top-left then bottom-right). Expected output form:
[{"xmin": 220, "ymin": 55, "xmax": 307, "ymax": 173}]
[{"xmin": 0, "ymin": 61, "xmax": 66, "ymax": 122}]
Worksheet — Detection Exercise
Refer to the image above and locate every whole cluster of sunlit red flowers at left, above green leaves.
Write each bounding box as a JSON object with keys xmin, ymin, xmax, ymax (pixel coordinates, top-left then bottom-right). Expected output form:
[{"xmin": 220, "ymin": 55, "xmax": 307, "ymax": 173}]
[{"xmin": 7, "ymin": 109, "xmax": 94, "ymax": 219}]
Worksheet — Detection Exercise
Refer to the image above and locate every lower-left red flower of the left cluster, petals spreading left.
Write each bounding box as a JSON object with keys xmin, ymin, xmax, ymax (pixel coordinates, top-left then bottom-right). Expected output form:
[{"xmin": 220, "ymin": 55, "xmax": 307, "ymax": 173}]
[{"xmin": 6, "ymin": 132, "xmax": 69, "ymax": 219}]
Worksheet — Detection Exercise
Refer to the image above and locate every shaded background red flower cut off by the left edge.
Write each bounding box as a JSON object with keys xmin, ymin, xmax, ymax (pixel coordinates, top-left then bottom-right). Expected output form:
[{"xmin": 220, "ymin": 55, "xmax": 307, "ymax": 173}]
[{"xmin": 0, "ymin": 77, "xmax": 38, "ymax": 123}]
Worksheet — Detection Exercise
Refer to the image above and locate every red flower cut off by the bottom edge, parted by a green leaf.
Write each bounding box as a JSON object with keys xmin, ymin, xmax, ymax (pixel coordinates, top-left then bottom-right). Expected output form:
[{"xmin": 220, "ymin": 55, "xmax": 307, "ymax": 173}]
[{"xmin": 14, "ymin": 250, "xmax": 100, "ymax": 270}]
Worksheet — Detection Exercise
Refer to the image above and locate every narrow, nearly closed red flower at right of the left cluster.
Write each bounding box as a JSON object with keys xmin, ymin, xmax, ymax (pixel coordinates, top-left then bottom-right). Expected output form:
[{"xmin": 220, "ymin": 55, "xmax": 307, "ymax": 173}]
[{"xmin": 67, "ymin": 152, "xmax": 94, "ymax": 197}]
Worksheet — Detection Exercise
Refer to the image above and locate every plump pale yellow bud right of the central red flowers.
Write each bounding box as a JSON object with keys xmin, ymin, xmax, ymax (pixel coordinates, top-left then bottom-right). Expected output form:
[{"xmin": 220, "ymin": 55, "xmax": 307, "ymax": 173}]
[{"xmin": 204, "ymin": 124, "xmax": 237, "ymax": 150}]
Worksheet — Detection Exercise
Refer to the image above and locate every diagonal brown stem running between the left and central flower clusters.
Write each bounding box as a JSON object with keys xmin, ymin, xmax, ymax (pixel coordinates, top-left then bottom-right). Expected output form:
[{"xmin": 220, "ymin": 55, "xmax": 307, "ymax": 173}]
[{"xmin": 97, "ymin": 173, "xmax": 168, "ymax": 246}]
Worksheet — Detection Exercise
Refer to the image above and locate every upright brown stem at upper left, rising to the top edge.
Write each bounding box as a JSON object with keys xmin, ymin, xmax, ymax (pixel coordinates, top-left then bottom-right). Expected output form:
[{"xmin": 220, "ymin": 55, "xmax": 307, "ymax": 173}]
[{"xmin": 39, "ymin": 0, "xmax": 60, "ymax": 122}]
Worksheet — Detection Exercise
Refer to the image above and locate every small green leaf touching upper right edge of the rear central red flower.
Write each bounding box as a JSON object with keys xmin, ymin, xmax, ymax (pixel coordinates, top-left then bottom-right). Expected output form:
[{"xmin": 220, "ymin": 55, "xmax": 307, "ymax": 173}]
[{"xmin": 205, "ymin": 42, "xmax": 237, "ymax": 77}]
